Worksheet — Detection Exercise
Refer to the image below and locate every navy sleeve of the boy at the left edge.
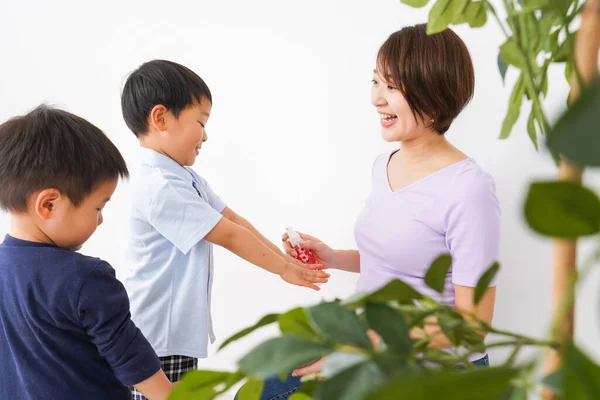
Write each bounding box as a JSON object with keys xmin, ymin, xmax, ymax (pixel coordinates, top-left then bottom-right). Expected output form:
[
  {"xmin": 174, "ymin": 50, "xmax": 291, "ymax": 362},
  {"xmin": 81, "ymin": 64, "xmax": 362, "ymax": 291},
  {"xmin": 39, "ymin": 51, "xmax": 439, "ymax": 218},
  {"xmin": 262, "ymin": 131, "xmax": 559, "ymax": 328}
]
[{"xmin": 77, "ymin": 263, "xmax": 161, "ymax": 386}]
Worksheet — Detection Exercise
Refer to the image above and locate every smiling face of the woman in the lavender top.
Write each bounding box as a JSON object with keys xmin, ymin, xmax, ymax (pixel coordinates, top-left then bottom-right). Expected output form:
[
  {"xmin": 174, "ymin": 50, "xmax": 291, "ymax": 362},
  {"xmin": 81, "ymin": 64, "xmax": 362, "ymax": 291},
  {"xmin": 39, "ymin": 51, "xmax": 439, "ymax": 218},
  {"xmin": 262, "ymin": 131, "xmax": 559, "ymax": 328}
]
[{"xmin": 371, "ymin": 70, "xmax": 424, "ymax": 142}]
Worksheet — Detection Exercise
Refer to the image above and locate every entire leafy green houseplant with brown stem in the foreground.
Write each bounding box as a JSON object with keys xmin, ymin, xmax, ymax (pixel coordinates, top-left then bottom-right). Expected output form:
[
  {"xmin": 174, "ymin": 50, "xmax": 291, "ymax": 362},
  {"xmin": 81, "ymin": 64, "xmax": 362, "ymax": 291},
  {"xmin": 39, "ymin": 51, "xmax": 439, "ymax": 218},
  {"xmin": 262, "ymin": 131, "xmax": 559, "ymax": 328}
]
[{"xmin": 171, "ymin": 0, "xmax": 600, "ymax": 400}]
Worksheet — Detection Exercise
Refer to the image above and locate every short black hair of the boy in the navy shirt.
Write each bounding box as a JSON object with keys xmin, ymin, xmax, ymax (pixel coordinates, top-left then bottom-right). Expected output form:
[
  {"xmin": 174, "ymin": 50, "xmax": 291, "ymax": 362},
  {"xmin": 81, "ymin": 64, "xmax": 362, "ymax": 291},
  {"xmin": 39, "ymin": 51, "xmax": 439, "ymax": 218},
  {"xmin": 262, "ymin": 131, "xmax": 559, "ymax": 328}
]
[{"xmin": 0, "ymin": 105, "xmax": 129, "ymax": 212}]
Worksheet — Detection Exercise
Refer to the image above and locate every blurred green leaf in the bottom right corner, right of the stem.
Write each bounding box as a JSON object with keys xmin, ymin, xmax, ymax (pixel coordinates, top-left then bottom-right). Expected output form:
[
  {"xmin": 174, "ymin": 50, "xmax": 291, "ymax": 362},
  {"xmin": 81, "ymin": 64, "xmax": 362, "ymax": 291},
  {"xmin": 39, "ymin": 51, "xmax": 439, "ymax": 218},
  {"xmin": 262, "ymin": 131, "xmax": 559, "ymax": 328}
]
[{"xmin": 564, "ymin": 343, "xmax": 600, "ymax": 400}]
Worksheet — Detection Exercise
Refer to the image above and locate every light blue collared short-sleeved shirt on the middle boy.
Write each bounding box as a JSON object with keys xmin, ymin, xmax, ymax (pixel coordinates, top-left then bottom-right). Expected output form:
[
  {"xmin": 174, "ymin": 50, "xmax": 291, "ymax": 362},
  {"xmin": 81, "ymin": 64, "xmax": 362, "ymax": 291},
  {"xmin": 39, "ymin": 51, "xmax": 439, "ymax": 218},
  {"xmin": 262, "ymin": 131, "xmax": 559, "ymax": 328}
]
[{"xmin": 123, "ymin": 148, "xmax": 225, "ymax": 358}]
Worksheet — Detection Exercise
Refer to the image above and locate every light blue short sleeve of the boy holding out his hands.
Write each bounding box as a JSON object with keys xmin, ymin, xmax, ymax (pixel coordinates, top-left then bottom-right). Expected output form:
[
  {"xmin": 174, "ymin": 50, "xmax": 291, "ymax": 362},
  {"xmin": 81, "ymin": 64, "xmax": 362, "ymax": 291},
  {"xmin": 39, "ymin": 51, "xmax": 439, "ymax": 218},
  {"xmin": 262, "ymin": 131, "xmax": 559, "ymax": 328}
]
[{"xmin": 148, "ymin": 180, "xmax": 222, "ymax": 254}]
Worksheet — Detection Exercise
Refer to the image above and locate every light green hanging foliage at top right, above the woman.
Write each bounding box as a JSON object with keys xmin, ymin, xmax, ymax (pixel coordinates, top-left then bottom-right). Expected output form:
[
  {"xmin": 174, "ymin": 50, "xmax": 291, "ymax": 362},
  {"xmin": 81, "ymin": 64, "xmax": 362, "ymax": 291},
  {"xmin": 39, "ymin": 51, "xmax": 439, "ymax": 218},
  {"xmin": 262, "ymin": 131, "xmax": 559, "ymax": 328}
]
[{"xmin": 402, "ymin": 0, "xmax": 583, "ymax": 153}]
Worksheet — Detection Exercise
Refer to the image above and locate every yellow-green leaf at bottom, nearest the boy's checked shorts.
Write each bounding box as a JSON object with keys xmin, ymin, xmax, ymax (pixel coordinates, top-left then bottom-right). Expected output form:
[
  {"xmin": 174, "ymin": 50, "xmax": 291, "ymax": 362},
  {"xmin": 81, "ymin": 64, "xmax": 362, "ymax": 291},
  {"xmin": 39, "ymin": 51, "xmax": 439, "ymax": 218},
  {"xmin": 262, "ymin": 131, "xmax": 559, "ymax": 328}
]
[{"xmin": 169, "ymin": 370, "xmax": 237, "ymax": 400}]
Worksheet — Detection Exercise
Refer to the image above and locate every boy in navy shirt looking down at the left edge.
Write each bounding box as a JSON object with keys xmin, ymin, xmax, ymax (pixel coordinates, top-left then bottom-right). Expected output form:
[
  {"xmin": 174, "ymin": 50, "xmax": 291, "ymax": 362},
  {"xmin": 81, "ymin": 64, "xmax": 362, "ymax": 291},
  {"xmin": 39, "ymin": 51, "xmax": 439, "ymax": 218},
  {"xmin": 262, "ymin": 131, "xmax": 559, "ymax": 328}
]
[{"xmin": 0, "ymin": 106, "xmax": 172, "ymax": 400}]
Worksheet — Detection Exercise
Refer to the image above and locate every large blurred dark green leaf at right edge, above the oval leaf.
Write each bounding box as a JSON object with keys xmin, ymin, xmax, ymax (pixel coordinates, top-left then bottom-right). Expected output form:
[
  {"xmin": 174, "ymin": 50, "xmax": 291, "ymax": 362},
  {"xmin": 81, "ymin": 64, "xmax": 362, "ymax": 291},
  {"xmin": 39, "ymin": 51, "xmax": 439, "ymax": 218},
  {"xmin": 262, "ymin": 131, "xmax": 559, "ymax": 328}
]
[{"xmin": 548, "ymin": 80, "xmax": 600, "ymax": 167}]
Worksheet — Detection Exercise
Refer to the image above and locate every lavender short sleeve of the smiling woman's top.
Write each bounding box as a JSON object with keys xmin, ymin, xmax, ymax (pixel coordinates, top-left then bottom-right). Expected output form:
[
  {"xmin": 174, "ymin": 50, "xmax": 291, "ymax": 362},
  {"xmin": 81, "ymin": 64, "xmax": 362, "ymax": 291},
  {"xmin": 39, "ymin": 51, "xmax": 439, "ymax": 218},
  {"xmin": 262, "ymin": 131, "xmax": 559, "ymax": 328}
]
[{"xmin": 446, "ymin": 170, "xmax": 500, "ymax": 287}]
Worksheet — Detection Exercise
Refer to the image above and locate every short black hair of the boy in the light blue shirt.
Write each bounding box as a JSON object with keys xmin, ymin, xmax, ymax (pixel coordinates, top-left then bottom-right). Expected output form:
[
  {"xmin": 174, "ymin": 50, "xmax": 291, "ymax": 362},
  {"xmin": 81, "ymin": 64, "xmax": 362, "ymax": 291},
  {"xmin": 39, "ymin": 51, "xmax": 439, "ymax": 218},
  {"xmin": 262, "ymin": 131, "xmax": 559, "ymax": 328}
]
[{"xmin": 121, "ymin": 60, "xmax": 212, "ymax": 136}]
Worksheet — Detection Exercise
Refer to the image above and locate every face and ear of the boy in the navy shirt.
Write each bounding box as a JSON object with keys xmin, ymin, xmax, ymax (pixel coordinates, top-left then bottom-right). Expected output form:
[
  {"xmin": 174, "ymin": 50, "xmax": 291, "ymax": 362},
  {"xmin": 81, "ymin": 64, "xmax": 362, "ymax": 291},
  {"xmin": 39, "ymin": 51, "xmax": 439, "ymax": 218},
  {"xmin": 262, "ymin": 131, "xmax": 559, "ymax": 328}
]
[{"xmin": 36, "ymin": 179, "xmax": 118, "ymax": 251}]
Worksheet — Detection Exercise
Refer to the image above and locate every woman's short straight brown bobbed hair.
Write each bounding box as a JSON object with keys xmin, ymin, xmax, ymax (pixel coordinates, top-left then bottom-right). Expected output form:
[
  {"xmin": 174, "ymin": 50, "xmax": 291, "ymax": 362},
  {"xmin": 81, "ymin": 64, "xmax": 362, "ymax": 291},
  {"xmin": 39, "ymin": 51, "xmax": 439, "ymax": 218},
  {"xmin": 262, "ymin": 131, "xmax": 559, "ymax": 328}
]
[{"xmin": 377, "ymin": 24, "xmax": 475, "ymax": 134}]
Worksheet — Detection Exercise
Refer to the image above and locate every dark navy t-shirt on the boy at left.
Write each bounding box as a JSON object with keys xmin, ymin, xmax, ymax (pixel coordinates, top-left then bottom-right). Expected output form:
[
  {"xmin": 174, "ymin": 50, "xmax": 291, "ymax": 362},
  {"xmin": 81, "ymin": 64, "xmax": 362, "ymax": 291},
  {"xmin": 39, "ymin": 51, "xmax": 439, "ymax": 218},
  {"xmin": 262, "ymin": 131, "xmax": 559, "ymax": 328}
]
[{"xmin": 0, "ymin": 236, "xmax": 160, "ymax": 400}]
